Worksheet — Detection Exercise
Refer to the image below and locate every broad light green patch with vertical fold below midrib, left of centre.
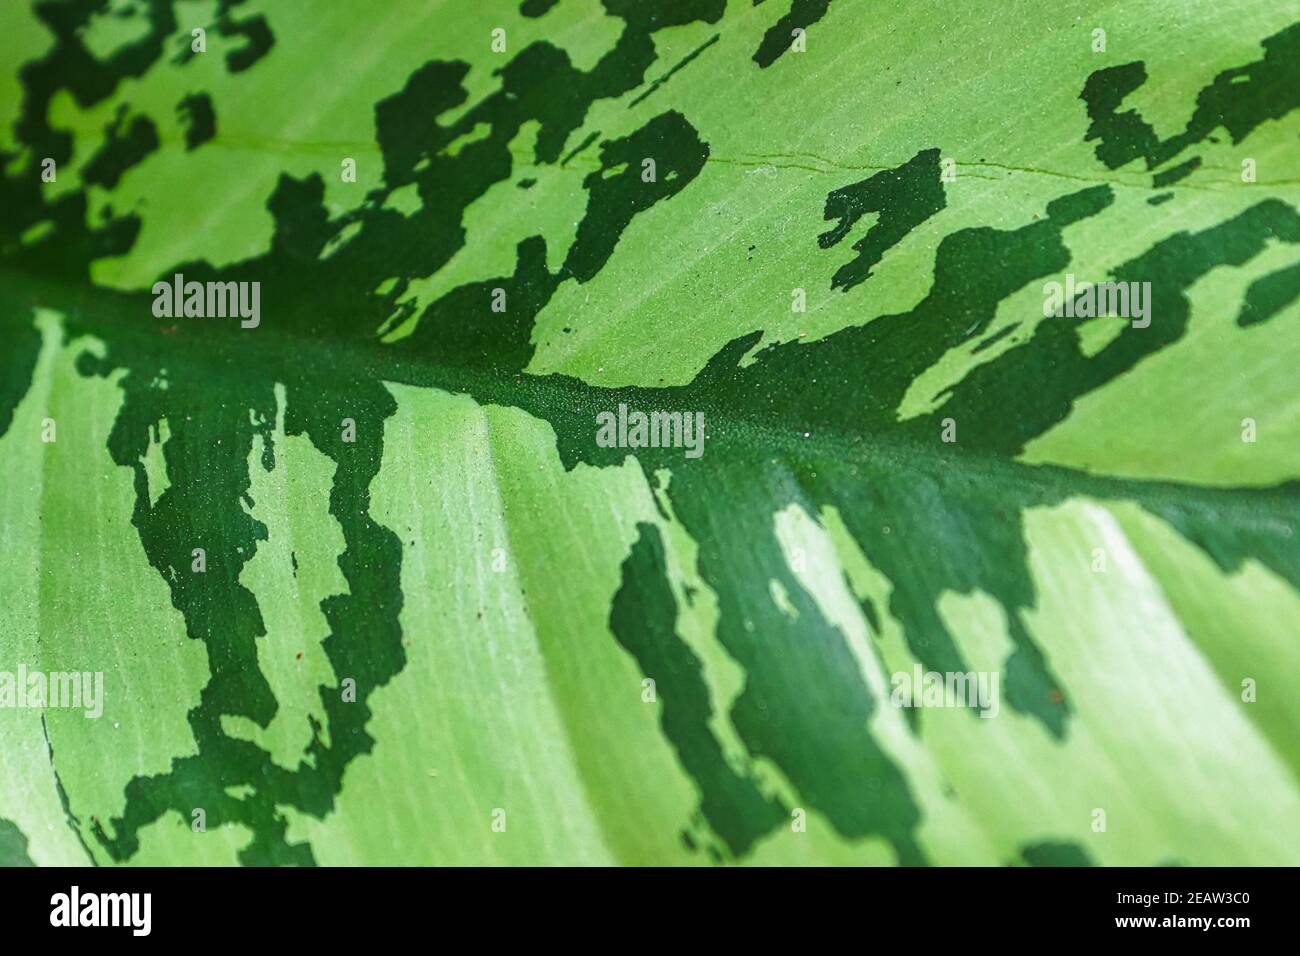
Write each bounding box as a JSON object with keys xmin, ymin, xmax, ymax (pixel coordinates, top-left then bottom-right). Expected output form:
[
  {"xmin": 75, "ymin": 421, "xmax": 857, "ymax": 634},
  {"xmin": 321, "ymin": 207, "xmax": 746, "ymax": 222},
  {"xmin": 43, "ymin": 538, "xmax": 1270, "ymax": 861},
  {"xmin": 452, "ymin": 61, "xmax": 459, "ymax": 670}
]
[{"xmin": 290, "ymin": 386, "xmax": 639, "ymax": 865}]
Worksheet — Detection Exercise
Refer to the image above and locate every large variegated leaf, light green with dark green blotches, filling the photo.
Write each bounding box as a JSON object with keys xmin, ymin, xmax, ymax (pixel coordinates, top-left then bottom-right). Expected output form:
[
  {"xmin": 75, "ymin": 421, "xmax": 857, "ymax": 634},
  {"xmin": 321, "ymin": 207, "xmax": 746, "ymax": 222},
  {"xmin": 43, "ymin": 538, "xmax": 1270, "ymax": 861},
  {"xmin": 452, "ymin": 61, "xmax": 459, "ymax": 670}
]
[{"xmin": 0, "ymin": 0, "xmax": 1300, "ymax": 865}]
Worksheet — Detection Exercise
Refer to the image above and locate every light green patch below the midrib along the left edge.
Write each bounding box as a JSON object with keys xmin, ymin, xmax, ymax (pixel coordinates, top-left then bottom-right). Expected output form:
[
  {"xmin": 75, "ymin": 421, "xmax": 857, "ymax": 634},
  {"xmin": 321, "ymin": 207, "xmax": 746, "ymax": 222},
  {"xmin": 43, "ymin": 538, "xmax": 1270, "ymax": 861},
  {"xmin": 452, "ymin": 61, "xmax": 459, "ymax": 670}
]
[{"xmin": 0, "ymin": 316, "xmax": 208, "ymax": 858}]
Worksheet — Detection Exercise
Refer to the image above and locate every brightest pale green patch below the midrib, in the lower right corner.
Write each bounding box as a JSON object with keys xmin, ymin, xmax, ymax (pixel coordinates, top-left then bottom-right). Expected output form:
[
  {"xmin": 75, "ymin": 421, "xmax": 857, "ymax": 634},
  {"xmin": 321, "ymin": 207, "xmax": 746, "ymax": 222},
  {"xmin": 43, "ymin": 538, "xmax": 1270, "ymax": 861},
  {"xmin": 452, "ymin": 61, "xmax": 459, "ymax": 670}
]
[{"xmin": 920, "ymin": 501, "xmax": 1300, "ymax": 866}]
